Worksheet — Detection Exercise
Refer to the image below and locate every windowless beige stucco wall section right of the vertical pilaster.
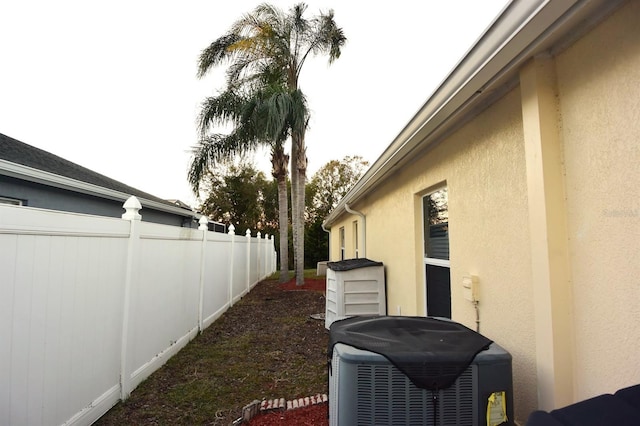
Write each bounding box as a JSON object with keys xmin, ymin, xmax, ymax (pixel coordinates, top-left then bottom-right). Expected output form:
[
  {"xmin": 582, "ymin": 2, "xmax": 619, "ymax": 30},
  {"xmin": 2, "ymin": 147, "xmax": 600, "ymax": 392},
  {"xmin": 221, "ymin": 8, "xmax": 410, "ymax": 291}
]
[{"xmin": 556, "ymin": 1, "xmax": 640, "ymax": 400}]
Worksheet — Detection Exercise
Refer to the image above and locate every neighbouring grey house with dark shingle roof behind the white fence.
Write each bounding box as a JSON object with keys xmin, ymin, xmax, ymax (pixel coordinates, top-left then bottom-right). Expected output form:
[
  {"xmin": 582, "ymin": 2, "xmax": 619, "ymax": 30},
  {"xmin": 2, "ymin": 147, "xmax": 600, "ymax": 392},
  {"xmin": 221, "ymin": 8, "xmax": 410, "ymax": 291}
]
[{"xmin": 0, "ymin": 133, "xmax": 200, "ymax": 228}]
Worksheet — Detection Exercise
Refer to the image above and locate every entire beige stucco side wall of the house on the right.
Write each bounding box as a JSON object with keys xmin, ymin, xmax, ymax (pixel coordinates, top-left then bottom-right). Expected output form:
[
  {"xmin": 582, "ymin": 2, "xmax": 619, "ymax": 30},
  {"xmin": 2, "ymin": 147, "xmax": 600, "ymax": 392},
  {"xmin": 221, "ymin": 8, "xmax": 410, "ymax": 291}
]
[{"xmin": 331, "ymin": 1, "xmax": 640, "ymax": 424}]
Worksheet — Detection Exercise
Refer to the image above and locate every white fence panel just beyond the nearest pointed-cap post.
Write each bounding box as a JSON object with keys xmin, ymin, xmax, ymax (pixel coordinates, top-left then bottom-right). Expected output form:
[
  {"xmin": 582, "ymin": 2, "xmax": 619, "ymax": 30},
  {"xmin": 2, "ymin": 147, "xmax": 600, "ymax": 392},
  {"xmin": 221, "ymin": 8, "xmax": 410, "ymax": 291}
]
[{"xmin": 128, "ymin": 222, "xmax": 202, "ymax": 387}]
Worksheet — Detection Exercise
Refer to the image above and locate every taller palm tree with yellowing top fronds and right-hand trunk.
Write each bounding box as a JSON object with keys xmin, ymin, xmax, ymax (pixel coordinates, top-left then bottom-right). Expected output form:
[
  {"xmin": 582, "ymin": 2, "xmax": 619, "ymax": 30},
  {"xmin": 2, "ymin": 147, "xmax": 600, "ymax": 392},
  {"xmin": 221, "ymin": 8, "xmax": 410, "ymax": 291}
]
[{"xmin": 199, "ymin": 3, "xmax": 346, "ymax": 285}]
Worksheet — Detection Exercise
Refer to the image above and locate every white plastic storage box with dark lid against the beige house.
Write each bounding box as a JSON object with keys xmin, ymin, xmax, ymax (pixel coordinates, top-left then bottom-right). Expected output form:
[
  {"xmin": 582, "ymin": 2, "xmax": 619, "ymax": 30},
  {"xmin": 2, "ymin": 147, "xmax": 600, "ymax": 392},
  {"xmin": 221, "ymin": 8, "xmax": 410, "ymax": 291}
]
[{"xmin": 324, "ymin": 258, "xmax": 387, "ymax": 329}]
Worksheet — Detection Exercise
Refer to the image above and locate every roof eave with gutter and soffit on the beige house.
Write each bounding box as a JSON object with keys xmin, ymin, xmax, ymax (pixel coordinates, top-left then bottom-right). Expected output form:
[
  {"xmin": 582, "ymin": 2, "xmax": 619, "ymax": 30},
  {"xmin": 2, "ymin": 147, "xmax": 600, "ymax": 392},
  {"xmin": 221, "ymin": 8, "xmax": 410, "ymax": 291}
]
[{"xmin": 323, "ymin": 0, "xmax": 623, "ymax": 228}]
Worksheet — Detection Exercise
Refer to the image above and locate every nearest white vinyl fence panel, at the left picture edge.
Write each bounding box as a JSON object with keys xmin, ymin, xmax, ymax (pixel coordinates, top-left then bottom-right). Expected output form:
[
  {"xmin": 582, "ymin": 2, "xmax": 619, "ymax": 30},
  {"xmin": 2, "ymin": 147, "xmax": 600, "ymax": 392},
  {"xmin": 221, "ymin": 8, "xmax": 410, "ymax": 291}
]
[{"xmin": 0, "ymin": 208, "xmax": 128, "ymax": 425}]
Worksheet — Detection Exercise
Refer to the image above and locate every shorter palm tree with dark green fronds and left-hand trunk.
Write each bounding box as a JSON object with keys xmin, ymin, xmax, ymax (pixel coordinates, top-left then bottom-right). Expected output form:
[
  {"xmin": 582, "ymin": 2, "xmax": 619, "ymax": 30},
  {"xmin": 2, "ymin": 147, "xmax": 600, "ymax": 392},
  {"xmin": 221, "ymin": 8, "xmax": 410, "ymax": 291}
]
[{"xmin": 188, "ymin": 84, "xmax": 307, "ymax": 282}]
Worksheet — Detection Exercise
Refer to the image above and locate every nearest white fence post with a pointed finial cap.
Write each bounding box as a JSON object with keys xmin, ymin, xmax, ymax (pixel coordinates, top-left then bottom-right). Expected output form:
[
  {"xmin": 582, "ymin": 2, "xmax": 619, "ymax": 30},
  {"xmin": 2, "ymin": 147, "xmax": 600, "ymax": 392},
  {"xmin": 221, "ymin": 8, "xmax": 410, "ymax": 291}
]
[{"xmin": 120, "ymin": 196, "xmax": 142, "ymax": 401}]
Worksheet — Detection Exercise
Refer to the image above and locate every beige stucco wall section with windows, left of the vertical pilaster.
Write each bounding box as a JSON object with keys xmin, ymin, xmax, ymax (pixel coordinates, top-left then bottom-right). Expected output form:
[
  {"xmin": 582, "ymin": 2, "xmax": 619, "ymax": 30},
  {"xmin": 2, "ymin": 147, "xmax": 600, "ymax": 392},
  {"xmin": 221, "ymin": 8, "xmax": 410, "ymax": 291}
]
[{"xmin": 332, "ymin": 90, "xmax": 537, "ymax": 419}]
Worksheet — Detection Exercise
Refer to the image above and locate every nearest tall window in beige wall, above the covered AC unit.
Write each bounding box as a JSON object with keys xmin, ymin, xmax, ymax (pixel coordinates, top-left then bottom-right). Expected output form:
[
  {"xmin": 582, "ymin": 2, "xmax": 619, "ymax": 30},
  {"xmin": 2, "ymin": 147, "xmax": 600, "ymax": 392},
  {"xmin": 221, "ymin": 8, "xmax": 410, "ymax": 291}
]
[{"xmin": 422, "ymin": 187, "xmax": 451, "ymax": 318}]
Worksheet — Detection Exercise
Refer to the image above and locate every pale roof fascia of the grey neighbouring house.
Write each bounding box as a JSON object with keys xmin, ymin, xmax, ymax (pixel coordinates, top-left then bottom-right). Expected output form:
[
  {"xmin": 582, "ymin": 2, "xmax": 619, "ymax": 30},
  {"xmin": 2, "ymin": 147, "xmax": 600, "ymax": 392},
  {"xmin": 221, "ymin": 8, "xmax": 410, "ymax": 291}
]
[{"xmin": 0, "ymin": 159, "xmax": 200, "ymax": 218}]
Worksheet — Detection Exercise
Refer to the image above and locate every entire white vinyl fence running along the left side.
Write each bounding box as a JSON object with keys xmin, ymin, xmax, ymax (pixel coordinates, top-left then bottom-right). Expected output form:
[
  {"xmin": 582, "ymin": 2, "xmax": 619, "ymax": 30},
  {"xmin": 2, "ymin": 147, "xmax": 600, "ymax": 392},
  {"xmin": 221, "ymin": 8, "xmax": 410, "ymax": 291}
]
[{"xmin": 0, "ymin": 197, "xmax": 276, "ymax": 426}]
